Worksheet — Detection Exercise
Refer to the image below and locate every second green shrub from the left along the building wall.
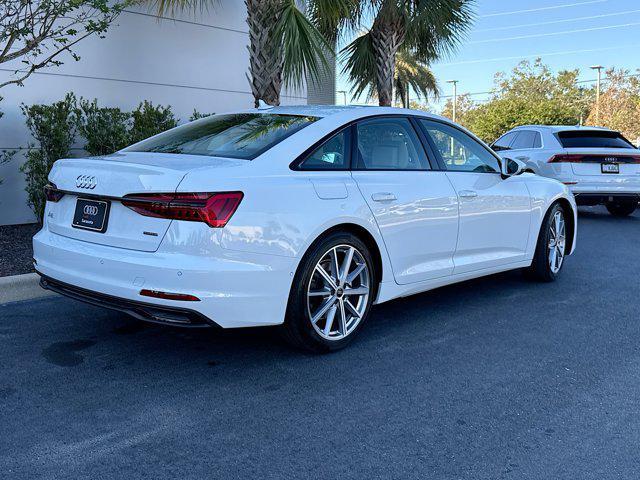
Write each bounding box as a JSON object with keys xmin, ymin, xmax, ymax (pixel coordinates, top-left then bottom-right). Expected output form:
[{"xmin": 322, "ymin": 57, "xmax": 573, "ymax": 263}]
[{"xmin": 79, "ymin": 99, "xmax": 131, "ymax": 155}]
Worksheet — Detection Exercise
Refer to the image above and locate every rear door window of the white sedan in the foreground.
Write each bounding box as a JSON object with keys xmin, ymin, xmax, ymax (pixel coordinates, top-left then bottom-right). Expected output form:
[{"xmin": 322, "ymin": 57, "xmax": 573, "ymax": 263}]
[{"xmin": 356, "ymin": 118, "xmax": 430, "ymax": 170}]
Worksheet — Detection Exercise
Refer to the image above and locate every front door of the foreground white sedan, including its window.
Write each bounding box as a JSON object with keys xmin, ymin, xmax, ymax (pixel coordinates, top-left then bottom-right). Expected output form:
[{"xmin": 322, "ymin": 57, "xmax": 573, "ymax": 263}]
[{"xmin": 419, "ymin": 120, "xmax": 531, "ymax": 274}]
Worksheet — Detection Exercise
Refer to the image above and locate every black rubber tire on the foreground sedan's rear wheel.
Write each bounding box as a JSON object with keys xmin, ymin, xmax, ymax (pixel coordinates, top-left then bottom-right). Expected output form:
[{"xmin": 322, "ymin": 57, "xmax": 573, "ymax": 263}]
[{"xmin": 280, "ymin": 232, "xmax": 377, "ymax": 353}]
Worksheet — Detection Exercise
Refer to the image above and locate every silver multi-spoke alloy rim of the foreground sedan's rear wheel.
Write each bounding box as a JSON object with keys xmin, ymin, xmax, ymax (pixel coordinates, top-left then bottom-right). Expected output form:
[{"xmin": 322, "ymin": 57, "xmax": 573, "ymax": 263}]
[{"xmin": 307, "ymin": 245, "xmax": 371, "ymax": 340}]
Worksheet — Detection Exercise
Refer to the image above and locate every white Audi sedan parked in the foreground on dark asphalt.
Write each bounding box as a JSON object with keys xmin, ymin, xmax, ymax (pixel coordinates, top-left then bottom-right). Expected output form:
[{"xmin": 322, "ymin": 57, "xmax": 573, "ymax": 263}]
[{"xmin": 34, "ymin": 106, "xmax": 576, "ymax": 351}]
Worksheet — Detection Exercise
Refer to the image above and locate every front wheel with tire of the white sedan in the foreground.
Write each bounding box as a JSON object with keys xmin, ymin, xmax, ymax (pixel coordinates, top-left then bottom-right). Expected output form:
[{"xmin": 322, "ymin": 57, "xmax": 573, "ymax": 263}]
[{"xmin": 527, "ymin": 203, "xmax": 567, "ymax": 282}]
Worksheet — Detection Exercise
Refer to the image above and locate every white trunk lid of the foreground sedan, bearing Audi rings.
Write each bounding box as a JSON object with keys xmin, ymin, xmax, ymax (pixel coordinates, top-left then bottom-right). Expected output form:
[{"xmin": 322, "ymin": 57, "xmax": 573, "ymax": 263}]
[{"xmin": 45, "ymin": 152, "xmax": 246, "ymax": 252}]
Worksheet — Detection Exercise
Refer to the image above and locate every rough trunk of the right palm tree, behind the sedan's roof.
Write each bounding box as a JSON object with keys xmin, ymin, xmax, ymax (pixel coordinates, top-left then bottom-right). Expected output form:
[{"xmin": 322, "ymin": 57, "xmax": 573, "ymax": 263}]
[{"xmin": 371, "ymin": 6, "xmax": 406, "ymax": 107}]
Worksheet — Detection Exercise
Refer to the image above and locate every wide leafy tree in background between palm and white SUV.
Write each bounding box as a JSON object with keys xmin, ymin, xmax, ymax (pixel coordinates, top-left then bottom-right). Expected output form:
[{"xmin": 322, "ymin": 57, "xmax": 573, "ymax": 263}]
[{"xmin": 443, "ymin": 59, "xmax": 590, "ymax": 142}]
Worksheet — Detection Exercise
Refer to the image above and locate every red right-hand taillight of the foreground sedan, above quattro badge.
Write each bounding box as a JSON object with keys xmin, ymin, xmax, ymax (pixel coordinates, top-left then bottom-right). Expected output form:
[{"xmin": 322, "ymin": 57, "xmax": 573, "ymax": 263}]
[{"xmin": 122, "ymin": 192, "xmax": 243, "ymax": 228}]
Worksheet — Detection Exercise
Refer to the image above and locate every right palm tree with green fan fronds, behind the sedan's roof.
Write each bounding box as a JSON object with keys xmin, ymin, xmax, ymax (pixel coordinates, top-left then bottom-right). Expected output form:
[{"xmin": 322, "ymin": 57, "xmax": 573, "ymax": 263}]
[{"xmin": 311, "ymin": 0, "xmax": 474, "ymax": 106}]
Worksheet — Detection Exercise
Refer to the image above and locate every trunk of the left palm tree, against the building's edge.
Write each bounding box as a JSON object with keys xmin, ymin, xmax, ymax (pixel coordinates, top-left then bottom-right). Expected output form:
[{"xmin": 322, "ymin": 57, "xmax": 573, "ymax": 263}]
[{"xmin": 245, "ymin": 0, "xmax": 284, "ymax": 108}]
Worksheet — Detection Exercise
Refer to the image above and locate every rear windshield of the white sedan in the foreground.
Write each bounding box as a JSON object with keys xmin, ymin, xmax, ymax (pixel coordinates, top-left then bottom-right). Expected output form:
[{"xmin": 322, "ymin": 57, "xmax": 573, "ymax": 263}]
[{"xmin": 127, "ymin": 113, "xmax": 317, "ymax": 160}]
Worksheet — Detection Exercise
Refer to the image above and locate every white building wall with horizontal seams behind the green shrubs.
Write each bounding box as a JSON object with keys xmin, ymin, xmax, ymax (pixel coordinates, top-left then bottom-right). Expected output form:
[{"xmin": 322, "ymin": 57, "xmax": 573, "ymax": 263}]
[{"xmin": 0, "ymin": 4, "xmax": 307, "ymax": 225}]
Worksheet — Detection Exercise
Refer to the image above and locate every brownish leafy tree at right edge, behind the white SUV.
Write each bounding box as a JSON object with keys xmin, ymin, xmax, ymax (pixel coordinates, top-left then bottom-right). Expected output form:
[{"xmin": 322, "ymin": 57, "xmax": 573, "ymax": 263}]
[{"xmin": 587, "ymin": 68, "xmax": 640, "ymax": 142}]
